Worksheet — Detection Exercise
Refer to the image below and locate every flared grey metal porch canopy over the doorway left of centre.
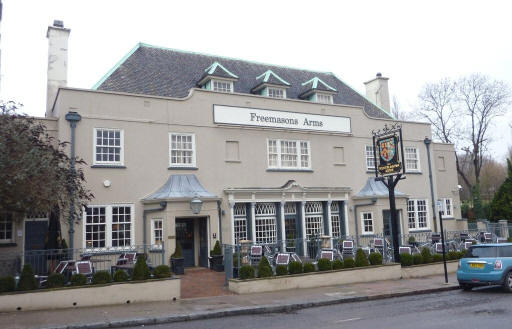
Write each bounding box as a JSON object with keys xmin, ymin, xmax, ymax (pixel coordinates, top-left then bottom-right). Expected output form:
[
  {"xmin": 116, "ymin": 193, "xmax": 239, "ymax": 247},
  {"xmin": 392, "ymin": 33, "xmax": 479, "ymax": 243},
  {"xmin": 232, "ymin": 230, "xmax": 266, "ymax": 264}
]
[{"xmin": 142, "ymin": 174, "xmax": 220, "ymax": 203}]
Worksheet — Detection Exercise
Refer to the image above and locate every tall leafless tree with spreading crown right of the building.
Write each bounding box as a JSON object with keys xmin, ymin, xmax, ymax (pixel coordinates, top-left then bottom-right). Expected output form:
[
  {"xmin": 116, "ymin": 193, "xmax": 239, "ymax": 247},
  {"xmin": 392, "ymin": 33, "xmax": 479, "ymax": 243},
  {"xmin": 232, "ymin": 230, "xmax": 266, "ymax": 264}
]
[{"xmin": 418, "ymin": 74, "xmax": 510, "ymax": 190}]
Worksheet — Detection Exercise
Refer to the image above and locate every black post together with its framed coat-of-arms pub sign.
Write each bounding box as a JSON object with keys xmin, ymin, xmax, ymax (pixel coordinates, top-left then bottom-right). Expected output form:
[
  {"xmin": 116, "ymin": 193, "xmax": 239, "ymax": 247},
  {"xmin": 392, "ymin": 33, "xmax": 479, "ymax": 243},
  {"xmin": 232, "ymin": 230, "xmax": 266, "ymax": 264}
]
[{"xmin": 372, "ymin": 123, "xmax": 405, "ymax": 263}]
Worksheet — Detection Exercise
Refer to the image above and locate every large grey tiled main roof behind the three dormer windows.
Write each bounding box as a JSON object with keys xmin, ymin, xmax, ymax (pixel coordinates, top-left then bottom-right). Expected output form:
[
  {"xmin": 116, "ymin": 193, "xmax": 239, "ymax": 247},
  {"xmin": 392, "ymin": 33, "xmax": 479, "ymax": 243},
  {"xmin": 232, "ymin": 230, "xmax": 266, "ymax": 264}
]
[{"xmin": 96, "ymin": 44, "xmax": 390, "ymax": 118}]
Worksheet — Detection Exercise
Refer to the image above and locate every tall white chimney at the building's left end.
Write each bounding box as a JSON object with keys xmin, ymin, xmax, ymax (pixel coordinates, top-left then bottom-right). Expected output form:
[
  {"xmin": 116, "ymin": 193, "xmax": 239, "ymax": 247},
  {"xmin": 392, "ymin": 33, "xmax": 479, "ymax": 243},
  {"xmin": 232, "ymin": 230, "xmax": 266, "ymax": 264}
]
[{"xmin": 46, "ymin": 20, "xmax": 71, "ymax": 117}]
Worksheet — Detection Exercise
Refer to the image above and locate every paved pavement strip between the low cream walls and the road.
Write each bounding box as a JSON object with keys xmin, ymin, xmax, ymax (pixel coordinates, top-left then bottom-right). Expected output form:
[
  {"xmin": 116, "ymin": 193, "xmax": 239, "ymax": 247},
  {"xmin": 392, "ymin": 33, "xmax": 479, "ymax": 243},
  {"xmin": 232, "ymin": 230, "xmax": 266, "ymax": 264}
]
[{"xmin": 0, "ymin": 275, "xmax": 457, "ymax": 329}]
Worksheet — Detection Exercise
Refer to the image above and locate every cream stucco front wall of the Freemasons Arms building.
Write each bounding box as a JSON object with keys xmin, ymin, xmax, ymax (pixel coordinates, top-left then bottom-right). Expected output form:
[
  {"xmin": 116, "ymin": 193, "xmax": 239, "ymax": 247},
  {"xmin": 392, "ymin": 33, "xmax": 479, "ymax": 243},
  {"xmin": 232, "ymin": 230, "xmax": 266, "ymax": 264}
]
[{"xmin": 45, "ymin": 88, "xmax": 460, "ymax": 252}]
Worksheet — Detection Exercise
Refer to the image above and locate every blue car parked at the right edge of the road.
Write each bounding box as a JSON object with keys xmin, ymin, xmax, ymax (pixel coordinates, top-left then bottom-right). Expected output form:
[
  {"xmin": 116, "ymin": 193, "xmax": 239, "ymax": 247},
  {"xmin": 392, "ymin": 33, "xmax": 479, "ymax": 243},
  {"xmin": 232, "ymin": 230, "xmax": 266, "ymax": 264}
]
[{"xmin": 457, "ymin": 243, "xmax": 512, "ymax": 292}]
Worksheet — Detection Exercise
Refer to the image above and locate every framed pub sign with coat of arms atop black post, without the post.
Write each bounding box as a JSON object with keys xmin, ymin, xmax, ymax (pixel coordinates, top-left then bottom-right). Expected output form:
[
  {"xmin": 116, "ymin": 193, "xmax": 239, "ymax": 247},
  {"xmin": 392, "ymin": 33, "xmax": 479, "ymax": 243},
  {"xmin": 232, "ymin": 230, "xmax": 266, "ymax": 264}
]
[{"xmin": 374, "ymin": 126, "xmax": 403, "ymax": 176}]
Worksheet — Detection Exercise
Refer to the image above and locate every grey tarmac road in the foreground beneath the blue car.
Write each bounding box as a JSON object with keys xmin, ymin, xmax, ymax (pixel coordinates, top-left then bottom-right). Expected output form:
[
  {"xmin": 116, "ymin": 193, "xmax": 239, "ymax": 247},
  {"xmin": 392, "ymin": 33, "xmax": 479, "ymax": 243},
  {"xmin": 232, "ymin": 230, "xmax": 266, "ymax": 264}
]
[{"xmin": 127, "ymin": 287, "xmax": 512, "ymax": 329}]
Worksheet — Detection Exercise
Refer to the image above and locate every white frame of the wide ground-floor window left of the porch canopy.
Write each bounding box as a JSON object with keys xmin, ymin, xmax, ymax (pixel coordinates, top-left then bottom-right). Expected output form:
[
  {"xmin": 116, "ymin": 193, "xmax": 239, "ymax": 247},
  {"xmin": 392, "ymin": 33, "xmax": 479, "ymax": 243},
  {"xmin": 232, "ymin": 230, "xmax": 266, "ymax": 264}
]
[{"xmin": 82, "ymin": 203, "xmax": 135, "ymax": 251}]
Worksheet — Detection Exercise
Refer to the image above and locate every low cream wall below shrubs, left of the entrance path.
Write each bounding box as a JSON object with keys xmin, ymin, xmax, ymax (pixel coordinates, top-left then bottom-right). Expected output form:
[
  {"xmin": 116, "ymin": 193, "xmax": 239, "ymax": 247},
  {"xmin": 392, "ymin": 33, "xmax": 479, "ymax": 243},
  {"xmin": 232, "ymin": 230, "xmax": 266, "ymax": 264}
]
[{"xmin": 0, "ymin": 278, "xmax": 180, "ymax": 312}]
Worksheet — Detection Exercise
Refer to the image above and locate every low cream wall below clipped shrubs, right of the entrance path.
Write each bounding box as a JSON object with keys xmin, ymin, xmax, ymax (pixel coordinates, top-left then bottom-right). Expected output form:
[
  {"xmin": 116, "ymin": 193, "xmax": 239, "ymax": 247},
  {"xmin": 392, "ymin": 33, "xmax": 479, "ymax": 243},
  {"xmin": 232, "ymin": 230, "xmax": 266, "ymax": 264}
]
[{"xmin": 229, "ymin": 264, "xmax": 401, "ymax": 294}]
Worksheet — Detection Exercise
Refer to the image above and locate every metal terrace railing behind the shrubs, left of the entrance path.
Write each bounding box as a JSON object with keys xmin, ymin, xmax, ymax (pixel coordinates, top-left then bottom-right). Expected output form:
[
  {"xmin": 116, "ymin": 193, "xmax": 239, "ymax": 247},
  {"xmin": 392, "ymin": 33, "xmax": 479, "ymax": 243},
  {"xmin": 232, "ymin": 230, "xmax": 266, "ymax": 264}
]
[{"xmin": 0, "ymin": 245, "xmax": 168, "ymax": 275}]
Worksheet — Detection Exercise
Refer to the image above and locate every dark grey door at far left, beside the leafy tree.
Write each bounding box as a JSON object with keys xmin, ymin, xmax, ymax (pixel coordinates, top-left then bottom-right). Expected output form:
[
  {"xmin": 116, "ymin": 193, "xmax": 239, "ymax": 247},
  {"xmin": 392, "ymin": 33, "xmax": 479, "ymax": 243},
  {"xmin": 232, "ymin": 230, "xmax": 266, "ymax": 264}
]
[{"xmin": 25, "ymin": 220, "xmax": 48, "ymax": 275}]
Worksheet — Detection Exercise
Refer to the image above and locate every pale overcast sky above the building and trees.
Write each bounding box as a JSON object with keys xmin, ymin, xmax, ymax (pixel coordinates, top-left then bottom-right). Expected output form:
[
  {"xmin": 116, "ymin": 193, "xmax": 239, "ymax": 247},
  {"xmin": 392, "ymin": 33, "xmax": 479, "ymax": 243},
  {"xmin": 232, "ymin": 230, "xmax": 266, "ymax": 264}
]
[{"xmin": 0, "ymin": 0, "xmax": 512, "ymax": 160}]
